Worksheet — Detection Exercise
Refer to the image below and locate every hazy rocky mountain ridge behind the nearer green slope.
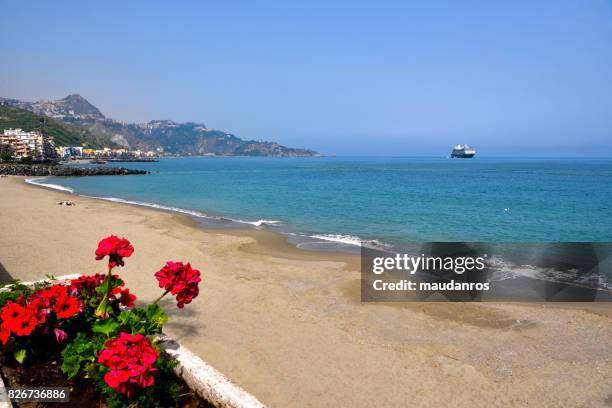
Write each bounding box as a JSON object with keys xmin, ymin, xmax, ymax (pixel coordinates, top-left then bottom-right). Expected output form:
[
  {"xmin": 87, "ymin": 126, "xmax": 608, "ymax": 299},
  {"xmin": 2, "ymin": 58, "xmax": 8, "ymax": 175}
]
[{"xmin": 0, "ymin": 95, "xmax": 318, "ymax": 157}]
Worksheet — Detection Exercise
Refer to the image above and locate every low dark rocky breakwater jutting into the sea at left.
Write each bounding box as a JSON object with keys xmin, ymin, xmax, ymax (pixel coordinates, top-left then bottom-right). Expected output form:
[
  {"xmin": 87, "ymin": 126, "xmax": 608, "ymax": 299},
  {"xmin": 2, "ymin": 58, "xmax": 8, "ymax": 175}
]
[{"xmin": 0, "ymin": 164, "xmax": 148, "ymax": 177}]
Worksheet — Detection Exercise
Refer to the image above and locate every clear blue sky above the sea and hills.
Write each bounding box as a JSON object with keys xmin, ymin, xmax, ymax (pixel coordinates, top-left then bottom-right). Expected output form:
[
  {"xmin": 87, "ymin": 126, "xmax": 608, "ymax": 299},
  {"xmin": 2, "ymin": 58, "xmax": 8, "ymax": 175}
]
[{"xmin": 0, "ymin": 0, "xmax": 612, "ymax": 157}]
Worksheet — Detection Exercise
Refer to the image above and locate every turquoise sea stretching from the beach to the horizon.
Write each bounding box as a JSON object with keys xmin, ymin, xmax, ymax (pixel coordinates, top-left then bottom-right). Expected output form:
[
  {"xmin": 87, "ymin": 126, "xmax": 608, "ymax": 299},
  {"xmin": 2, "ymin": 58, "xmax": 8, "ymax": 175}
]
[{"xmin": 31, "ymin": 157, "xmax": 612, "ymax": 244}]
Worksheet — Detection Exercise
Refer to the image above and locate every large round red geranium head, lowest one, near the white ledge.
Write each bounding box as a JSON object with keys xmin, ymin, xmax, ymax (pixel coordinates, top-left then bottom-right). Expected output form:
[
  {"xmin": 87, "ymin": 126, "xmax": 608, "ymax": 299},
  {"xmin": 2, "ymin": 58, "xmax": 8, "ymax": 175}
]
[{"xmin": 98, "ymin": 332, "xmax": 158, "ymax": 397}]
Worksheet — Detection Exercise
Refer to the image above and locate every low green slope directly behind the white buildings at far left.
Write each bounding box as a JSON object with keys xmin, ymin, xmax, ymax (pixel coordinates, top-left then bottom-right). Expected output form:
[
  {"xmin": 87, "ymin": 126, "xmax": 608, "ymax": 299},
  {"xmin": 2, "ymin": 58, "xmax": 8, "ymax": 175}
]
[{"xmin": 0, "ymin": 105, "xmax": 106, "ymax": 148}]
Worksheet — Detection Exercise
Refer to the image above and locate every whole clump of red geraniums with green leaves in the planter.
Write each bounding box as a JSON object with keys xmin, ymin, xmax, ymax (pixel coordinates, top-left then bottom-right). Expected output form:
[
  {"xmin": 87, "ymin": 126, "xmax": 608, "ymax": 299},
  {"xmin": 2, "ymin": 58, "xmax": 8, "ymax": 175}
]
[{"xmin": 0, "ymin": 235, "xmax": 201, "ymax": 406}]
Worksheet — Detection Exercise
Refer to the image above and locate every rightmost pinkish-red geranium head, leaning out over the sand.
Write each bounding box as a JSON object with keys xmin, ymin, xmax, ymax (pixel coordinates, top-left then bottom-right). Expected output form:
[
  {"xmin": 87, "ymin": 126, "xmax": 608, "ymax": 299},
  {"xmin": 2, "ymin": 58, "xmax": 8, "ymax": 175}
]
[{"xmin": 155, "ymin": 261, "xmax": 202, "ymax": 309}]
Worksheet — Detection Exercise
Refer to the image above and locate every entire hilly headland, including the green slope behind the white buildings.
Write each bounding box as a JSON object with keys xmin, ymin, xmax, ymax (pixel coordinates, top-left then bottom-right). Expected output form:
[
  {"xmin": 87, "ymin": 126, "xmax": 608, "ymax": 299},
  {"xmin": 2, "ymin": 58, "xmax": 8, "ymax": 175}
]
[{"xmin": 0, "ymin": 94, "xmax": 319, "ymax": 157}]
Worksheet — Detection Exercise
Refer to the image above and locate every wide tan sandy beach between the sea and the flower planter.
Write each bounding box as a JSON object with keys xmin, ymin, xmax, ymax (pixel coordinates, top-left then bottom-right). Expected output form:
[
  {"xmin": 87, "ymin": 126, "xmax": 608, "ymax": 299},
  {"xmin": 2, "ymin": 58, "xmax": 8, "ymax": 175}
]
[{"xmin": 0, "ymin": 177, "xmax": 612, "ymax": 407}]
